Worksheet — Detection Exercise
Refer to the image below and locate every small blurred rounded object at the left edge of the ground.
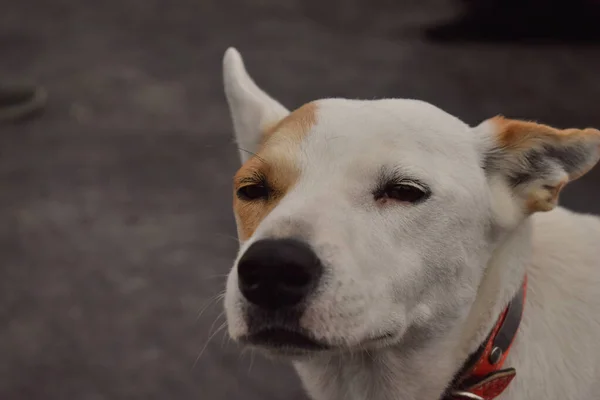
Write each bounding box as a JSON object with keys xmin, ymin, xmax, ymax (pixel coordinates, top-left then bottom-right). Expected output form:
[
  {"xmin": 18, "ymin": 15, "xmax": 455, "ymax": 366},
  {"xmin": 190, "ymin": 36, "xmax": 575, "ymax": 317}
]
[{"xmin": 0, "ymin": 84, "xmax": 47, "ymax": 122}]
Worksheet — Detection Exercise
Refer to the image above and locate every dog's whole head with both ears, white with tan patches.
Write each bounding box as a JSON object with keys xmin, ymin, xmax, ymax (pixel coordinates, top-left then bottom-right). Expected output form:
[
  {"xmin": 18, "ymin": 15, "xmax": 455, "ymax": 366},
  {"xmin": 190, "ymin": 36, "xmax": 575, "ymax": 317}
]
[{"xmin": 224, "ymin": 49, "xmax": 600, "ymax": 354}]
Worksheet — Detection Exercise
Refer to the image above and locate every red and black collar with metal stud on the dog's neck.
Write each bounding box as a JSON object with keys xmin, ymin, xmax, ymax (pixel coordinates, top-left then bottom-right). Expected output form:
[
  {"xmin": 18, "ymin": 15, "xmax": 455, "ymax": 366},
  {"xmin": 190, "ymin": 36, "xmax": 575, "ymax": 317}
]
[{"xmin": 442, "ymin": 275, "xmax": 527, "ymax": 400}]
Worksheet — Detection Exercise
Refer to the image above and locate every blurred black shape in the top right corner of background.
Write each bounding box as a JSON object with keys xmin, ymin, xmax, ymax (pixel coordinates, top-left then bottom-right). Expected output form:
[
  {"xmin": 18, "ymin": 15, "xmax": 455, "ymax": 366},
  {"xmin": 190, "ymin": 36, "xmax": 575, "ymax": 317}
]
[{"xmin": 426, "ymin": 0, "xmax": 600, "ymax": 42}]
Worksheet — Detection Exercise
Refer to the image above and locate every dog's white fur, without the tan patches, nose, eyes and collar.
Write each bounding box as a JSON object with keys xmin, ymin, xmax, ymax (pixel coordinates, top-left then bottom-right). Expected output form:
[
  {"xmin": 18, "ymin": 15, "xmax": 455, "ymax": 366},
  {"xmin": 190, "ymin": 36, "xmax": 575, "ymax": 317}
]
[{"xmin": 224, "ymin": 50, "xmax": 600, "ymax": 400}]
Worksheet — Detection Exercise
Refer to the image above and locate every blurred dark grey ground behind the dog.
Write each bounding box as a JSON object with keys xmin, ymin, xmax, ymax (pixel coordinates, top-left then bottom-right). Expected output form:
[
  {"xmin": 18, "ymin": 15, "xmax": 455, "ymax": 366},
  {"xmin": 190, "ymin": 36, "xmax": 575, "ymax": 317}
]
[{"xmin": 0, "ymin": 0, "xmax": 600, "ymax": 400}]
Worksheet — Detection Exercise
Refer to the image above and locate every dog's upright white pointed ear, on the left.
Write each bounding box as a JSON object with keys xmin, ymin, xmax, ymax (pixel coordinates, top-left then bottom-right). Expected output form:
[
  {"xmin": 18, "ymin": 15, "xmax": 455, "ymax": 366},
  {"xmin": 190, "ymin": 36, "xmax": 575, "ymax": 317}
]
[{"xmin": 223, "ymin": 47, "xmax": 289, "ymax": 163}]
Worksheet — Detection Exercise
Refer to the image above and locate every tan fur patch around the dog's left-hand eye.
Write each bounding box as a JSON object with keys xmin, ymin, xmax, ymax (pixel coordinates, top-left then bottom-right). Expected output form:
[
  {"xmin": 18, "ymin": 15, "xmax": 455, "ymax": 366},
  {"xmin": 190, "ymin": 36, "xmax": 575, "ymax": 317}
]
[{"xmin": 233, "ymin": 102, "xmax": 317, "ymax": 240}]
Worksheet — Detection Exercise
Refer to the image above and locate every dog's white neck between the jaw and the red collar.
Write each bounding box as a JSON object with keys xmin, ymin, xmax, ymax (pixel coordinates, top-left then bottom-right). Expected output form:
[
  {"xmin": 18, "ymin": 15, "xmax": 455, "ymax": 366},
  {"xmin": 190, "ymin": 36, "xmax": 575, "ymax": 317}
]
[{"xmin": 294, "ymin": 221, "xmax": 531, "ymax": 400}]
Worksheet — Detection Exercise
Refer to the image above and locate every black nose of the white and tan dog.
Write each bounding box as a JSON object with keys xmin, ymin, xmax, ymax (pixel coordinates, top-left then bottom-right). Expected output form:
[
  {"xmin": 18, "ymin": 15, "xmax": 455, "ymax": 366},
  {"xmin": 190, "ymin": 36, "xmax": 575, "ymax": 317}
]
[{"xmin": 238, "ymin": 239, "xmax": 323, "ymax": 310}]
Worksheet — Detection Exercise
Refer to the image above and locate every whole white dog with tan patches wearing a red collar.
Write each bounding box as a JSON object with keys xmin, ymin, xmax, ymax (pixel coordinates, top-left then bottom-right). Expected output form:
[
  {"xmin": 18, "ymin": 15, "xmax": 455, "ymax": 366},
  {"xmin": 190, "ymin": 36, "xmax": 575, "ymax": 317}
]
[{"xmin": 224, "ymin": 49, "xmax": 600, "ymax": 400}]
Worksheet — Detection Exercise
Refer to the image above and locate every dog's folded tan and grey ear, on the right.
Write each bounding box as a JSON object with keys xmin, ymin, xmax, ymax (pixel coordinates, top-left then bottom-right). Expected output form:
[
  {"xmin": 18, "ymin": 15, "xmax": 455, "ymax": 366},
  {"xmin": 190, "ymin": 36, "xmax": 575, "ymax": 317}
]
[{"xmin": 475, "ymin": 117, "xmax": 600, "ymax": 214}]
